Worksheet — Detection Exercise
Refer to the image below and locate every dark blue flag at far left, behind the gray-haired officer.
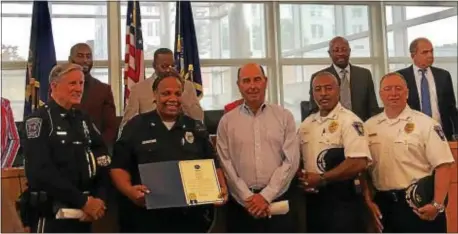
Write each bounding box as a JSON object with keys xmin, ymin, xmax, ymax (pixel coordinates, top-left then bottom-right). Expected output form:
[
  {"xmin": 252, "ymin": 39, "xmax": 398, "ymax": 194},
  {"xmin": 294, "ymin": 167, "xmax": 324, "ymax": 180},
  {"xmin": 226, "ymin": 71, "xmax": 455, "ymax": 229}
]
[{"xmin": 24, "ymin": 1, "xmax": 56, "ymax": 118}]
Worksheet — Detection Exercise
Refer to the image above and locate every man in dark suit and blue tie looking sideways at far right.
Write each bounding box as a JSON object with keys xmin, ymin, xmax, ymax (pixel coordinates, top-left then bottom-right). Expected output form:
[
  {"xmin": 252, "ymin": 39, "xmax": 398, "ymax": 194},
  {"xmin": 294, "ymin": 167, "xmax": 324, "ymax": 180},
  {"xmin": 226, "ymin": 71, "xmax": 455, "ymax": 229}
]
[{"xmin": 398, "ymin": 38, "xmax": 458, "ymax": 140}]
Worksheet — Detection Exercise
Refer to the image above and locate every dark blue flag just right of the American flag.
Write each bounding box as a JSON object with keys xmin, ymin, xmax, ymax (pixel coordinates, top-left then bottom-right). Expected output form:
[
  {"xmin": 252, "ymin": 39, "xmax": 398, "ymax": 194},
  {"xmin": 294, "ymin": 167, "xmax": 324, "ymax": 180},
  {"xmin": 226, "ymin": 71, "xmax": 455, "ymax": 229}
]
[{"xmin": 175, "ymin": 1, "xmax": 203, "ymax": 98}]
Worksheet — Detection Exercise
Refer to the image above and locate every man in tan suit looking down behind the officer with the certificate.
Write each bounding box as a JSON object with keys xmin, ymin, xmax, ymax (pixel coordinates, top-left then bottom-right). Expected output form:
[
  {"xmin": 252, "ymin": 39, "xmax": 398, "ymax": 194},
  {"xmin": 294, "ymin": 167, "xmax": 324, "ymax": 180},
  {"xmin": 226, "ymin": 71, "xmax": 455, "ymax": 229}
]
[{"xmin": 119, "ymin": 48, "xmax": 204, "ymax": 130}]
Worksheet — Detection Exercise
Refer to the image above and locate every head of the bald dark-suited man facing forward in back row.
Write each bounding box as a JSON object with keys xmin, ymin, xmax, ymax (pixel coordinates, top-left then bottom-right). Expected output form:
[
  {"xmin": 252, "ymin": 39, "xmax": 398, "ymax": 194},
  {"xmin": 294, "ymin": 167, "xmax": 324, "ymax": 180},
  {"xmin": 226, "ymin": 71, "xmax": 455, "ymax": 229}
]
[{"xmin": 328, "ymin": 36, "xmax": 351, "ymax": 69}]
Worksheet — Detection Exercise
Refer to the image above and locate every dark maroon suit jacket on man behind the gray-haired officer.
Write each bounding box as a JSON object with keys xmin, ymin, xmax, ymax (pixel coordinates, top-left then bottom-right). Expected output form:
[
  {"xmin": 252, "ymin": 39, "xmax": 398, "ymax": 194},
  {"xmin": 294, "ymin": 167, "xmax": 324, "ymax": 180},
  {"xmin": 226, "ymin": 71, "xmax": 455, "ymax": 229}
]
[{"xmin": 76, "ymin": 76, "xmax": 117, "ymax": 146}]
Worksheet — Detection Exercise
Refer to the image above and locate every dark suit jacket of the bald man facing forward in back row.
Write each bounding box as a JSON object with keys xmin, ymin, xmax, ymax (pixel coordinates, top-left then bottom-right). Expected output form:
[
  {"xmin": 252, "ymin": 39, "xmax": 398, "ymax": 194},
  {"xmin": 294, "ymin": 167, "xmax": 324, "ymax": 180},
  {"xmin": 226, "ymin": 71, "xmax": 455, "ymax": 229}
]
[{"xmin": 309, "ymin": 64, "xmax": 381, "ymax": 121}]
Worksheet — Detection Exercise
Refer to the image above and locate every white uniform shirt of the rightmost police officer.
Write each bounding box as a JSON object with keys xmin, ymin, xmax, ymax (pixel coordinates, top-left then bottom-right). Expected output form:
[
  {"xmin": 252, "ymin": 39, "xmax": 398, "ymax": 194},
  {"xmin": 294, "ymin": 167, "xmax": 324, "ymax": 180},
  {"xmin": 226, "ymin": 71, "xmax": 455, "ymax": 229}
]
[{"xmin": 365, "ymin": 106, "xmax": 454, "ymax": 191}]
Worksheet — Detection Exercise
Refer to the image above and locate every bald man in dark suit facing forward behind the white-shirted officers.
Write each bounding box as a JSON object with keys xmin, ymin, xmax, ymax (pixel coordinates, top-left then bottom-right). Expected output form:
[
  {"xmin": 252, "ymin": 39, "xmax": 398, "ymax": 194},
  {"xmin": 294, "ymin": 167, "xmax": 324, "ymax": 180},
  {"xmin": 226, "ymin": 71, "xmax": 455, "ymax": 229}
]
[{"xmin": 309, "ymin": 37, "xmax": 380, "ymax": 121}]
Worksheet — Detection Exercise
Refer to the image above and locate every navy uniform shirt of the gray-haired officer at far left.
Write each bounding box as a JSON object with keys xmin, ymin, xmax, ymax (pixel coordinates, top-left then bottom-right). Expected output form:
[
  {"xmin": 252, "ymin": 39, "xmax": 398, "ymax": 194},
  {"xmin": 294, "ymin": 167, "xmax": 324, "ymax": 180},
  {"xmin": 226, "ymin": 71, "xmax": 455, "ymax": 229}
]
[{"xmin": 24, "ymin": 100, "xmax": 111, "ymax": 208}]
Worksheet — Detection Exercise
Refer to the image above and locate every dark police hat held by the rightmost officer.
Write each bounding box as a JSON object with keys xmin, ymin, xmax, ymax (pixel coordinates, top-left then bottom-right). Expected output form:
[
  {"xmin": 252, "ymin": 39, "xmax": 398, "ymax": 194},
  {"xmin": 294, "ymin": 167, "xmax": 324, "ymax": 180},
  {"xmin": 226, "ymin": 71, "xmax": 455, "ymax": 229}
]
[{"xmin": 406, "ymin": 174, "xmax": 448, "ymax": 208}]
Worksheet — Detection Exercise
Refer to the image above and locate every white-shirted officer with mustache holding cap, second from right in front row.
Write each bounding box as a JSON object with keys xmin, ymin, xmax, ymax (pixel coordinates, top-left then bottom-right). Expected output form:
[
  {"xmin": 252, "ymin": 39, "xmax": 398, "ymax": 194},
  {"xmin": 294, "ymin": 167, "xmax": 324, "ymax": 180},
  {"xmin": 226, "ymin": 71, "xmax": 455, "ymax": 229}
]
[{"xmin": 299, "ymin": 72, "xmax": 371, "ymax": 232}]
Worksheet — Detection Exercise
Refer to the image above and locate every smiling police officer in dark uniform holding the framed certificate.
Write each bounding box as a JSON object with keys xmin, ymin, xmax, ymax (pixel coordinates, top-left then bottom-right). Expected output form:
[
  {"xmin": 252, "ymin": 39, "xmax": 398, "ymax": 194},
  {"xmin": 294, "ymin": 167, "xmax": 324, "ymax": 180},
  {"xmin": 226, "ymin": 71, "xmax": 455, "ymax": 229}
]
[{"xmin": 110, "ymin": 72, "xmax": 227, "ymax": 232}]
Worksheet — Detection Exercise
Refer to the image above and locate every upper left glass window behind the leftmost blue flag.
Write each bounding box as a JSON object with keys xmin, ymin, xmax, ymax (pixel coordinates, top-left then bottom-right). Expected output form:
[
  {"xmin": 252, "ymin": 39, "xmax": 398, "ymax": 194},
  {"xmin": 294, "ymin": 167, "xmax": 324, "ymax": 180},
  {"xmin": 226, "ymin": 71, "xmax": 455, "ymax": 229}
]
[{"xmin": 2, "ymin": 2, "xmax": 108, "ymax": 61}]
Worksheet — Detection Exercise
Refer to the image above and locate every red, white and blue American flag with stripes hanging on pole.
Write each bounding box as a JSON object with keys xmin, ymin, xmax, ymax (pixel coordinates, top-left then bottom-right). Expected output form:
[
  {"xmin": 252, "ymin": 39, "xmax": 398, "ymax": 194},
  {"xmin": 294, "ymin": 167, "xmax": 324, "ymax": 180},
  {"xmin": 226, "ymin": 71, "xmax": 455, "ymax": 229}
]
[{"xmin": 124, "ymin": 1, "xmax": 145, "ymax": 106}]
